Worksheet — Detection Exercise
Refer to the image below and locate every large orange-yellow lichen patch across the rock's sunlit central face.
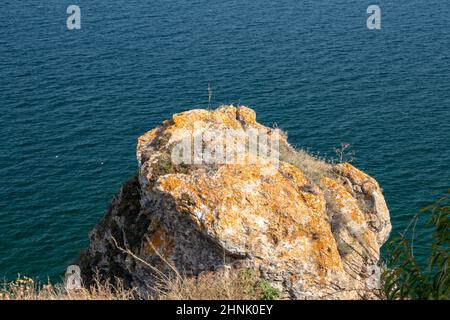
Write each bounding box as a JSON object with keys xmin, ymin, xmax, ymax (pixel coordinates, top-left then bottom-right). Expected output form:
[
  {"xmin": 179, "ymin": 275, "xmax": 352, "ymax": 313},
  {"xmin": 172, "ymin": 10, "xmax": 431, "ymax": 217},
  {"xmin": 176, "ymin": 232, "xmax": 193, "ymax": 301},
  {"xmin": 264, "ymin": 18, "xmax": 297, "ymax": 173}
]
[{"xmin": 158, "ymin": 163, "xmax": 342, "ymax": 270}]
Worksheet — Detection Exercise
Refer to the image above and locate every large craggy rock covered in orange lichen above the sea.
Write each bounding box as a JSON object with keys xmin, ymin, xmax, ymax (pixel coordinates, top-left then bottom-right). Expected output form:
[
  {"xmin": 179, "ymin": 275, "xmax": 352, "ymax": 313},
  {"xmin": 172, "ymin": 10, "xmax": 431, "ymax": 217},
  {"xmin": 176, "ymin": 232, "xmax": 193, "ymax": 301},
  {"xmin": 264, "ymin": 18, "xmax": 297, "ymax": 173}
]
[{"xmin": 79, "ymin": 106, "xmax": 391, "ymax": 299}]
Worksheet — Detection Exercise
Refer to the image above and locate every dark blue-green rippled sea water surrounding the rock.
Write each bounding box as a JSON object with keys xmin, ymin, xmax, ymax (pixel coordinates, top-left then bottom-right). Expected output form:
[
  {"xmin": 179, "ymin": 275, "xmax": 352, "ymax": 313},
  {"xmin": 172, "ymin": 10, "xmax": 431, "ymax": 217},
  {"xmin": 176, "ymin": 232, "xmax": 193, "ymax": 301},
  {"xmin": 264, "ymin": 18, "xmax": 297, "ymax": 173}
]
[{"xmin": 0, "ymin": 0, "xmax": 450, "ymax": 279}]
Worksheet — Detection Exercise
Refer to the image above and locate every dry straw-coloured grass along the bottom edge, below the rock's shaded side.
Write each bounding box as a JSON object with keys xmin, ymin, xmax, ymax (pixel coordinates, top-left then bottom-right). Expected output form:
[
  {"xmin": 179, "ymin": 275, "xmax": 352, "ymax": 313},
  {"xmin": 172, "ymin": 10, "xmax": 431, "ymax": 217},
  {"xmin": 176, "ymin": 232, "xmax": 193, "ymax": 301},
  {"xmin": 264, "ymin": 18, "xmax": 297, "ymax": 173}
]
[{"xmin": 0, "ymin": 269, "xmax": 279, "ymax": 300}]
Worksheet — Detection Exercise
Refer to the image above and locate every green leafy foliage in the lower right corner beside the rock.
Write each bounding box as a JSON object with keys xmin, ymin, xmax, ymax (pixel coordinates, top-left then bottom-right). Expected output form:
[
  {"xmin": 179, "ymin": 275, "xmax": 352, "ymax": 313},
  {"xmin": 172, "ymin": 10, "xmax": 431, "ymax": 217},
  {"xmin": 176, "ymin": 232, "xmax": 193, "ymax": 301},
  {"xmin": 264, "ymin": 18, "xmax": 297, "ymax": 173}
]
[{"xmin": 382, "ymin": 190, "xmax": 450, "ymax": 300}]
